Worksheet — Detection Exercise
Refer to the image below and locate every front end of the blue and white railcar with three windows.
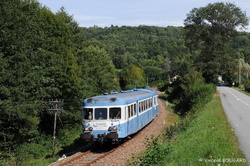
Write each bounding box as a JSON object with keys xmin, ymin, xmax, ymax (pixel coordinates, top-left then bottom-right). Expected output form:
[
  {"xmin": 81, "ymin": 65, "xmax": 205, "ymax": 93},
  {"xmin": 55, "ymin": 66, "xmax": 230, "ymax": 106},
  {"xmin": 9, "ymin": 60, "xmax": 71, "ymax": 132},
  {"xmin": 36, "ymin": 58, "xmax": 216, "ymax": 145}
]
[{"xmin": 81, "ymin": 106, "xmax": 125, "ymax": 143}]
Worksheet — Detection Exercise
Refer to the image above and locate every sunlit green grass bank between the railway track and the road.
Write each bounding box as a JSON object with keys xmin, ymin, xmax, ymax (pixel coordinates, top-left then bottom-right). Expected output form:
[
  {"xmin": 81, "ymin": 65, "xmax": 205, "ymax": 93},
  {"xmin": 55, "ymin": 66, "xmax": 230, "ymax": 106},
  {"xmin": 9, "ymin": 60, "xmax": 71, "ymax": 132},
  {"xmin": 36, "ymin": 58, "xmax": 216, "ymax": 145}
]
[{"xmin": 130, "ymin": 96, "xmax": 247, "ymax": 166}]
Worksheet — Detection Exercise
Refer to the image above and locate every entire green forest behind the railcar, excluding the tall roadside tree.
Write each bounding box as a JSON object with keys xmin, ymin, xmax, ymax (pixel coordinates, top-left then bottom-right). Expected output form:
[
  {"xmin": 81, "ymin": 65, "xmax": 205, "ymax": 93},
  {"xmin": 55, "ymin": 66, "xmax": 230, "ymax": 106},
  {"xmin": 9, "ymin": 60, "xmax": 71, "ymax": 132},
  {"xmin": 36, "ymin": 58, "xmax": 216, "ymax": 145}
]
[{"xmin": 0, "ymin": 0, "xmax": 250, "ymax": 165}]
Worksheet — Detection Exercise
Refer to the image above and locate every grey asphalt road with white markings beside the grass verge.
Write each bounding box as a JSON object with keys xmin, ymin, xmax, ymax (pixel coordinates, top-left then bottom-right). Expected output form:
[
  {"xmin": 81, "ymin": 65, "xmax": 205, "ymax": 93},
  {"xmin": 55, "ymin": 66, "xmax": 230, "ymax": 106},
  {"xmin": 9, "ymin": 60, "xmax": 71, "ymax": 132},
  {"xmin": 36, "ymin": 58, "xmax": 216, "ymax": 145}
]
[{"xmin": 217, "ymin": 87, "xmax": 250, "ymax": 165}]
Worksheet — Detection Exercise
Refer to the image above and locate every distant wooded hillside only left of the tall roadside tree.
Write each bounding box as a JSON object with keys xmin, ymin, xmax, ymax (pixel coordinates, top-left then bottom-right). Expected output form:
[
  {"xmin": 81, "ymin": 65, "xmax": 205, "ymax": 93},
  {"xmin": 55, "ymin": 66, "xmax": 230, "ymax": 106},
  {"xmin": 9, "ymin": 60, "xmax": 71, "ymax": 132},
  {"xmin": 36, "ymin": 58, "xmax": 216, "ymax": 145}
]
[{"xmin": 82, "ymin": 26, "xmax": 189, "ymax": 80}]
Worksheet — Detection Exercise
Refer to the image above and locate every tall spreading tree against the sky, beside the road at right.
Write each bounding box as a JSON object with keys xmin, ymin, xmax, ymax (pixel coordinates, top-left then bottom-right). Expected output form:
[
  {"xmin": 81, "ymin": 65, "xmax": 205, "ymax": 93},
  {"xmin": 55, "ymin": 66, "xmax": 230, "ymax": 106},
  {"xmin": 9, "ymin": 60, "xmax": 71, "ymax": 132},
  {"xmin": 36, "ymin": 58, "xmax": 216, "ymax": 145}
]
[{"xmin": 184, "ymin": 3, "xmax": 249, "ymax": 82}]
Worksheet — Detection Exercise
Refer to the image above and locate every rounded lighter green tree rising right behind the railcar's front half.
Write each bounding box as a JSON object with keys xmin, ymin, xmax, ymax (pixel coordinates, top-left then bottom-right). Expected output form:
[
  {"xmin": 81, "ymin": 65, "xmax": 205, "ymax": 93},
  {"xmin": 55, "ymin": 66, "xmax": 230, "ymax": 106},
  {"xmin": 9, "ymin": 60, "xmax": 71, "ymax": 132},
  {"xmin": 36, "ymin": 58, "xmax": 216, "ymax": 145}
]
[{"xmin": 77, "ymin": 41, "xmax": 119, "ymax": 97}]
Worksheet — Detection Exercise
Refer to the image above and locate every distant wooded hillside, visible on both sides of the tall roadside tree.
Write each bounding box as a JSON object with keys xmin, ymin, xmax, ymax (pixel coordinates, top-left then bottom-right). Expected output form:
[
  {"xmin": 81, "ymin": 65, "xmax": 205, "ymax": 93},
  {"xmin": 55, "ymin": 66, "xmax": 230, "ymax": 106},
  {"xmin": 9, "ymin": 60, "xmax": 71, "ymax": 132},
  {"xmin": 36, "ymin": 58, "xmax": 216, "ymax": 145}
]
[{"xmin": 82, "ymin": 25, "xmax": 250, "ymax": 83}]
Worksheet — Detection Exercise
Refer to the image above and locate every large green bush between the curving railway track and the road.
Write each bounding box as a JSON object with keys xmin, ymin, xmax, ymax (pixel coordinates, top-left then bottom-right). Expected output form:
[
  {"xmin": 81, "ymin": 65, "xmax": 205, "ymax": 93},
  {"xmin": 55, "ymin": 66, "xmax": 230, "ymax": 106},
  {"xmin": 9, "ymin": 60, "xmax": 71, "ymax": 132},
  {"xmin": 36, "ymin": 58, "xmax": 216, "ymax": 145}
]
[{"xmin": 169, "ymin": 70, "xmax": 216, "ymax": 115}]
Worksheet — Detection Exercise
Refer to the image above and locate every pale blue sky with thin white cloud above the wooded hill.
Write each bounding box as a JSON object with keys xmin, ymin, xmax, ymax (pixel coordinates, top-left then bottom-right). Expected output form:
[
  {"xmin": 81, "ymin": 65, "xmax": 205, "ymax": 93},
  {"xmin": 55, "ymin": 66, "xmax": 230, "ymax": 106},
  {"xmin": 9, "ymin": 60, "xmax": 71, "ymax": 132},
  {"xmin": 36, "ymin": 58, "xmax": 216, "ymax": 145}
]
[{"xmin": 38, "ymin": 0, "xmax": 250, "ymax": 32}]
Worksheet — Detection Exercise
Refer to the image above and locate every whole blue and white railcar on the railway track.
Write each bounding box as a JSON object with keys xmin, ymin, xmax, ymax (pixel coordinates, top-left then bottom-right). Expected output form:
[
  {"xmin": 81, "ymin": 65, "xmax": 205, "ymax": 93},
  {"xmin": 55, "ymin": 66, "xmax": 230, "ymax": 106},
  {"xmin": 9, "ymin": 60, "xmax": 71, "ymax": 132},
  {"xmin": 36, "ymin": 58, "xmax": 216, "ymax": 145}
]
[{"xmin": 81, "ymin": 88, "xmax": 158, "ymax": 143}]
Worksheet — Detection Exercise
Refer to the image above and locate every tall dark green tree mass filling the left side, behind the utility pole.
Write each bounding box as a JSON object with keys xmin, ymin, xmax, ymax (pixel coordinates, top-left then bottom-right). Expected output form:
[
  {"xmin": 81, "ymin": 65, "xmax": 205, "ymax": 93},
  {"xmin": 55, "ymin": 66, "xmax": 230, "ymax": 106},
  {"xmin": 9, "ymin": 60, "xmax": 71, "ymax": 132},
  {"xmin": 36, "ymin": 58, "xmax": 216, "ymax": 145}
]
[{"xmin": 0, "ymin": 0, "xmax": 81, "ymax": 149}]
